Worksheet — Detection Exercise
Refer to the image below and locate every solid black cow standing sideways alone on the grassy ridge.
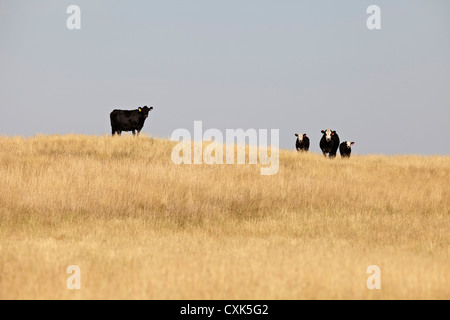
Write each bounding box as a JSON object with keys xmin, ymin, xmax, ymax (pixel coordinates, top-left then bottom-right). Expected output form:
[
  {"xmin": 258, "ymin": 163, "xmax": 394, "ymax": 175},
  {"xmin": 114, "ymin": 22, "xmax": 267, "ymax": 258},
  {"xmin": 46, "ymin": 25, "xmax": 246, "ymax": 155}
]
[{"xmin": 110, "ymin": 106, "xmax": 153, "ymax": 136}]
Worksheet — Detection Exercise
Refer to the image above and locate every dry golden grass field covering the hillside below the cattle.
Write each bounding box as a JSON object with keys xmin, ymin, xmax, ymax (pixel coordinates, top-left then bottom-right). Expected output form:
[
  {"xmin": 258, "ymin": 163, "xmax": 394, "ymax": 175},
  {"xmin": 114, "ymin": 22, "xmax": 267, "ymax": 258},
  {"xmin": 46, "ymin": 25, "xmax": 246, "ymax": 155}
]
[{"xmin": 0, "ymin": 135, "xmax": 450, "ymax": 299}]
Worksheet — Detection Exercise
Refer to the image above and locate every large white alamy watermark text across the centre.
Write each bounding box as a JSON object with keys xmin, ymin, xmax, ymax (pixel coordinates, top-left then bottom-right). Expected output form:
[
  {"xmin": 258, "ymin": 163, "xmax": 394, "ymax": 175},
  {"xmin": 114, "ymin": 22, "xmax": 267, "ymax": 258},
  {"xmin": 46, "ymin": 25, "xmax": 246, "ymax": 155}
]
[{"xmin": 171, "ymin": 121, "xmax": 280, "ymax": 175}]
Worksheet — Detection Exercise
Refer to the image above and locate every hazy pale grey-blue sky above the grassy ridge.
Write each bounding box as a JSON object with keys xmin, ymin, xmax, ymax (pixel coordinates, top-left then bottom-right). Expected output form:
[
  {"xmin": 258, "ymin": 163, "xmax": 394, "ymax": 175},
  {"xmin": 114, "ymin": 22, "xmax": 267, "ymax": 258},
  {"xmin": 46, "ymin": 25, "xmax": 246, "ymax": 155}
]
[{"xmin": 0, "ymin": 0, "xmax": 450, "ymax": 154}]
